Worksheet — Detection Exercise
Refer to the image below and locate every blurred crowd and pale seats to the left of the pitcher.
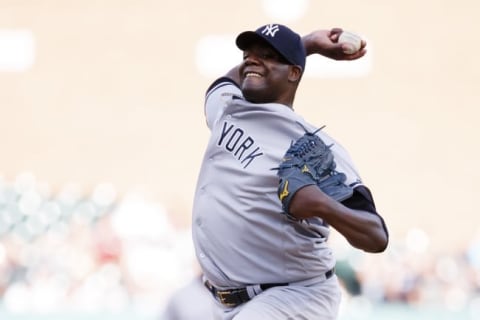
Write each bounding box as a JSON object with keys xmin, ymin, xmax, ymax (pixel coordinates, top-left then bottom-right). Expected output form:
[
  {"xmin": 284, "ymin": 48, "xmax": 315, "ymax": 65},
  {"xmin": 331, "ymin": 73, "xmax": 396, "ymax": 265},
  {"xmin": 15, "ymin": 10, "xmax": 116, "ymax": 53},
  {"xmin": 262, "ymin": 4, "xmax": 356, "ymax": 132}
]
[{"xmin": 0, "ymin": 173, "xmax": 196, "ymax": 315}]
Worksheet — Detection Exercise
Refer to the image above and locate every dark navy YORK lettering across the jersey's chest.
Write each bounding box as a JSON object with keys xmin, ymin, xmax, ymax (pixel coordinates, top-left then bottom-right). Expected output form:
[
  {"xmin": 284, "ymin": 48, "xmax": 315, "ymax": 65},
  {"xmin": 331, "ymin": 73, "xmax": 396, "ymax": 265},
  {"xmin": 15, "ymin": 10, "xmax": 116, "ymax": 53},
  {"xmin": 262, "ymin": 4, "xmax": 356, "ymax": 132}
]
[{"xmin": 217, "ymin": 121, "xmax": 263, "ymax": 169}]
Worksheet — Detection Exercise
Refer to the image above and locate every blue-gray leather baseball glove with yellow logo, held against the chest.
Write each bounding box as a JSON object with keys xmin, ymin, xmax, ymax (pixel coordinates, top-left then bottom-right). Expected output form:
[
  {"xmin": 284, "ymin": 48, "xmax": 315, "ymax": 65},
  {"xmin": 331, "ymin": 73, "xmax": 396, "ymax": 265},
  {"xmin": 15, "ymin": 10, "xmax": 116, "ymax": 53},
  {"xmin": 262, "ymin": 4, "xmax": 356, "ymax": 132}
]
[{"xmin": 275, "ymin": 123, "xmax": 353, "ymax": 214}]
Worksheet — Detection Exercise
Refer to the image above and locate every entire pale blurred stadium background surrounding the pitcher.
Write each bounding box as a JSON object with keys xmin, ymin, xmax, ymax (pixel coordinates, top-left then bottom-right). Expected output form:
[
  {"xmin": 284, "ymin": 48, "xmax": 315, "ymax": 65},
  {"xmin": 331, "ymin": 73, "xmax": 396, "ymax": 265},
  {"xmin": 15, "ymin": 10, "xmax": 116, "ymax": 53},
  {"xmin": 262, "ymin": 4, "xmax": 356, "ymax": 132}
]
[{"xmin": 0, "ymin": 0, "xmax": 480, "ymax": 320}]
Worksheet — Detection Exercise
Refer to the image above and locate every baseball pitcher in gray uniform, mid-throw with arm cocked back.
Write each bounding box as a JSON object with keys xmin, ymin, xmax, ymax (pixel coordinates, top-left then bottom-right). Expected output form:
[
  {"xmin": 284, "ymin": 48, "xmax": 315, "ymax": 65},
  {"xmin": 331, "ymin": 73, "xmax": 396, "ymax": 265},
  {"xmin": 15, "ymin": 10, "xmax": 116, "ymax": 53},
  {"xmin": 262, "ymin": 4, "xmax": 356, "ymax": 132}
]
[{"xmin": 192, "ymin": 24, "xmax": 388, "ymax": 320}]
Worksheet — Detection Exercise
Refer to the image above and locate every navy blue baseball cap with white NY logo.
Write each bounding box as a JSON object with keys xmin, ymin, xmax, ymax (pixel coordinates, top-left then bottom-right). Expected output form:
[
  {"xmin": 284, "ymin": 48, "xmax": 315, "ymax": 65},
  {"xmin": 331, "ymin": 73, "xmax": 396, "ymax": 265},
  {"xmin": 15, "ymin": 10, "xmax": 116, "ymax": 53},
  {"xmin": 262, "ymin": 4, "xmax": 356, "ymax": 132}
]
[{"xmin": 235, "ymin": 24, "xmax": 307, "ymax": 71}]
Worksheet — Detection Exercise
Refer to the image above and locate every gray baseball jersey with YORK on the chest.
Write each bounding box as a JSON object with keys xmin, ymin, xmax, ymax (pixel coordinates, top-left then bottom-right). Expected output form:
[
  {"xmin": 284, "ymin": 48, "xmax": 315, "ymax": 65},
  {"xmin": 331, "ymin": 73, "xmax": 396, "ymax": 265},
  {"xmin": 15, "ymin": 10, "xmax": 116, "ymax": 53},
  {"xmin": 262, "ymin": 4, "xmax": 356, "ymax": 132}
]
[{"xmin": 192, "ymin": 78, "xmax": 361, "ymax": 287}]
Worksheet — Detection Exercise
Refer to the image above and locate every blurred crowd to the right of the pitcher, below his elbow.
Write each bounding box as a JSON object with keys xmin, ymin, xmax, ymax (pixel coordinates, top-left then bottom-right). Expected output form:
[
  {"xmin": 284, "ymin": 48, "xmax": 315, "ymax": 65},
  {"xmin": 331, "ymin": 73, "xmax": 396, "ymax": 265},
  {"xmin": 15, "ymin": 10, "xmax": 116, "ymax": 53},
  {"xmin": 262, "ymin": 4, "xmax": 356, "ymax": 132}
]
[{"xmin": 337, "ymin": 229, "xmax": 480, "ymax": 319}]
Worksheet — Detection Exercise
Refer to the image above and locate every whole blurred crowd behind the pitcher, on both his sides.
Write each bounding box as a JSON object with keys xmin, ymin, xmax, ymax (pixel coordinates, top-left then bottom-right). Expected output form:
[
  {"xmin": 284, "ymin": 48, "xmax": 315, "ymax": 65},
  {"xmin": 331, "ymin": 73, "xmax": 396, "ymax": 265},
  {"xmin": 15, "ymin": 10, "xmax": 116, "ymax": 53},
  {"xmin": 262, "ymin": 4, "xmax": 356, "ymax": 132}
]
[{"xmin": 0, "ymin": 173, "xmax": 480, "ymax": 317}]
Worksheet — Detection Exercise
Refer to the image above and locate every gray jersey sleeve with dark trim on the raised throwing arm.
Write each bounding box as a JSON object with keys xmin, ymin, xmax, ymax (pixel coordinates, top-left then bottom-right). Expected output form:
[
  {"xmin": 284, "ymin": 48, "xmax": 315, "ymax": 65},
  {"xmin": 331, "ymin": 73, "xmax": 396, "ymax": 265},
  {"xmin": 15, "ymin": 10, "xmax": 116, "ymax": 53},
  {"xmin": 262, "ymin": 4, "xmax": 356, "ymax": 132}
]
[{"xmin": 205, "ymin": 77, "xmax": 242, "ymax": 129}]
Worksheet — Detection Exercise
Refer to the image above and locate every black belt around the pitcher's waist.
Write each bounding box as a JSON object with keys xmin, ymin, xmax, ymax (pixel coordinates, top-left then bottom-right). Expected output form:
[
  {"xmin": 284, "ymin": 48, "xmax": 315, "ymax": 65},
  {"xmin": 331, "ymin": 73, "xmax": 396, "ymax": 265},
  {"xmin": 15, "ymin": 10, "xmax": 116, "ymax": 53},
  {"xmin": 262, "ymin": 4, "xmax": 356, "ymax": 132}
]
[{"xmin": 204, "ymin": 268, "xmax": 335, "ymax": 308}]
